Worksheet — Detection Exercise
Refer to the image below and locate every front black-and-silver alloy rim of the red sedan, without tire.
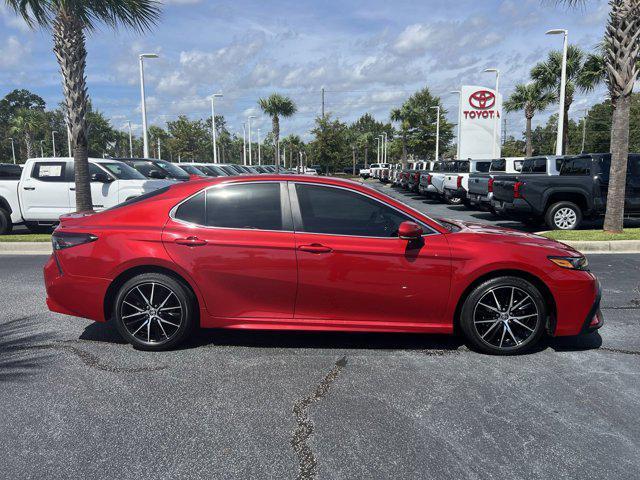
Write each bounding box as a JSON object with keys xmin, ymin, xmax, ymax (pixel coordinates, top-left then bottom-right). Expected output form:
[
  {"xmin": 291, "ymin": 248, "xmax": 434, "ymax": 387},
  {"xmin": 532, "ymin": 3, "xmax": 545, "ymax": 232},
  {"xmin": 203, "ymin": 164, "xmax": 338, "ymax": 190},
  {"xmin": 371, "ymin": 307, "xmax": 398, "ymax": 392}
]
[{"xmin": 473, "ymin": 285, "xmax": 541, "ymax": 350}]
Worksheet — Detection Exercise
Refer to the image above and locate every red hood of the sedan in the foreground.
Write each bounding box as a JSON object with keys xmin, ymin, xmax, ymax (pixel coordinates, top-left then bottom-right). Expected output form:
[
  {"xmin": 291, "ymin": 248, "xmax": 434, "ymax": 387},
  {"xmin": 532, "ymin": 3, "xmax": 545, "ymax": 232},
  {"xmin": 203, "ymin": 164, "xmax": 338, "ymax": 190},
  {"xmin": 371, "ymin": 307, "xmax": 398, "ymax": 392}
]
[{"xmin": 443, "ymin": 219, "xmax": 581, "ymax": 256}]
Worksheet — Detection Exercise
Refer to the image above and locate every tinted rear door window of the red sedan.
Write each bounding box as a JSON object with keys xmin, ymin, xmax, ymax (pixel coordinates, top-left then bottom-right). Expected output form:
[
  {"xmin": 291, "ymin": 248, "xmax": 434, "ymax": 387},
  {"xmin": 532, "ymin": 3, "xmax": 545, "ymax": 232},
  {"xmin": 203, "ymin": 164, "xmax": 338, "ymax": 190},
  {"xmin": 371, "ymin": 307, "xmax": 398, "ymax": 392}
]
[{"xmin": 206, "ymin": 183, "xmax": 282, "ymax": 230}]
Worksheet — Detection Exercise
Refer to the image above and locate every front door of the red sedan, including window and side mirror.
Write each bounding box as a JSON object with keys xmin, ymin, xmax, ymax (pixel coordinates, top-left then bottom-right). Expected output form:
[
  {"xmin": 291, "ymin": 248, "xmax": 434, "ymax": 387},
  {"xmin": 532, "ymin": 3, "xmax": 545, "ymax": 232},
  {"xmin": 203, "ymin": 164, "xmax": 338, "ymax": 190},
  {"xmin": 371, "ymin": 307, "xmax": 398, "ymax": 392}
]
[{"xmin": 289, "ymin": 182, "xmax": 451, "ymax": 328}]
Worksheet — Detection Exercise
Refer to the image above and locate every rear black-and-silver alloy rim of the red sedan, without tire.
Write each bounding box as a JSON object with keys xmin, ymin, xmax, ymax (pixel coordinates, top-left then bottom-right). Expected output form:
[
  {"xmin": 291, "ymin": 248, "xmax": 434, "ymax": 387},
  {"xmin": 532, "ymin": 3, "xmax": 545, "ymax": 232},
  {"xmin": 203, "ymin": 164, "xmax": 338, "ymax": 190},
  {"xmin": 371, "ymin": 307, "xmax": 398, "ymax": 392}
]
[{"xmin": 120, "ymin": 282, "xmax": 185, "ymax": 344}]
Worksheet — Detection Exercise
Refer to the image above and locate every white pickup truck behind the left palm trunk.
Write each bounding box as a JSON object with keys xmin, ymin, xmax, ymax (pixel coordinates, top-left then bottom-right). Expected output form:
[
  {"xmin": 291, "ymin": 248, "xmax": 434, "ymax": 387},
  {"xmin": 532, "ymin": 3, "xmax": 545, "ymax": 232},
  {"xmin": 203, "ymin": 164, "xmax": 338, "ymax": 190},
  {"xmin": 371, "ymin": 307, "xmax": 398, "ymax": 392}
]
[{"xmin": 0, "ymin": 158, "xmax": 175, "ymax": 235}]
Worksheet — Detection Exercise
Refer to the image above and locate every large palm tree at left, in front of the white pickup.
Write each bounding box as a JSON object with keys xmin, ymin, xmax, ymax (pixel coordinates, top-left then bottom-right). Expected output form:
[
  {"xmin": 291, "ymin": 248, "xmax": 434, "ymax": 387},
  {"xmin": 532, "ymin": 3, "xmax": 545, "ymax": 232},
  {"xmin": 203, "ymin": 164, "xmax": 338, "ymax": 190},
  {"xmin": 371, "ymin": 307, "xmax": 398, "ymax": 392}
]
[{"xmin": 5, "ymin": 0, "xmax": 160, "ymax": 211}]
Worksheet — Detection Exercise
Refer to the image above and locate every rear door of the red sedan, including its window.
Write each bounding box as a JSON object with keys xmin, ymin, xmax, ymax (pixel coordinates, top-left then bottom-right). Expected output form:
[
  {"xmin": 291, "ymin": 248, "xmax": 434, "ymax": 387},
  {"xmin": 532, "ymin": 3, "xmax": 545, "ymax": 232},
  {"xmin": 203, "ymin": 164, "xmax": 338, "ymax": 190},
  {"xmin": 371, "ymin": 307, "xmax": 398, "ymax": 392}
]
[{"xmin": 163, "ymin": 181, "xmax": 297, "ymax": 320}]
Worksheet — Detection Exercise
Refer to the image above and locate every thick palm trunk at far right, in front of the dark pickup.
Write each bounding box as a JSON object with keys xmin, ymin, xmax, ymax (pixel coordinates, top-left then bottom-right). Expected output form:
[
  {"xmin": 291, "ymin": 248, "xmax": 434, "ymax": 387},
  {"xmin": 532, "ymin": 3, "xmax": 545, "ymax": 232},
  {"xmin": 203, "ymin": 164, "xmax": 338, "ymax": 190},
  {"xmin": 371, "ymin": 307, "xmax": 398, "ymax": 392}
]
[{"xmin": 558, "ymin": 0, "xmax": 640, "ymax": 232}]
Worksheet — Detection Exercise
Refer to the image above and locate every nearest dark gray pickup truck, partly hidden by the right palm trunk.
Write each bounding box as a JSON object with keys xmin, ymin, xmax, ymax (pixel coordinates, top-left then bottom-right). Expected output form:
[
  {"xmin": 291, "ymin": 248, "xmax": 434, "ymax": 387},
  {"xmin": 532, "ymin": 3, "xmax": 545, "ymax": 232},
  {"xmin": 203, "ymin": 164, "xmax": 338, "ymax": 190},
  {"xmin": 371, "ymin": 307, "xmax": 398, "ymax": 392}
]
[{"xmin": 494, "ymin": 153, "xmax": 640, "ymax": 230}]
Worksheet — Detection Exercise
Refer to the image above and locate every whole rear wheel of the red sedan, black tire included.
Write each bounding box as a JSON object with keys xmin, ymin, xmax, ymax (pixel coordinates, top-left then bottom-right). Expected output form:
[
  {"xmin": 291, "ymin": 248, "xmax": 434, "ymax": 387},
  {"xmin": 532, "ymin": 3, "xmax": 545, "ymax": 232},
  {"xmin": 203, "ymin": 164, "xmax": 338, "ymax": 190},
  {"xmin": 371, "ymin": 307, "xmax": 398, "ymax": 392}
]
[{"xmin": 113, "ymin": 273, "xmax": 198, "ymax": 351}]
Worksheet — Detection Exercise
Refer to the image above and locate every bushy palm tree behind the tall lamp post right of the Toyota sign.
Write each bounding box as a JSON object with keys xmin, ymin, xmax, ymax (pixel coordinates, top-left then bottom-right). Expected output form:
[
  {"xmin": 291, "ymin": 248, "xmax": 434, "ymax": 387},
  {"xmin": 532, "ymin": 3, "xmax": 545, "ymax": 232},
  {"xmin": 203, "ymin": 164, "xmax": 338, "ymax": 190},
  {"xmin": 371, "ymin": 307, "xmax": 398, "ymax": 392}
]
[{"xmin": 531, "ymin": 45, "xmax": 597, "ymax": 152}]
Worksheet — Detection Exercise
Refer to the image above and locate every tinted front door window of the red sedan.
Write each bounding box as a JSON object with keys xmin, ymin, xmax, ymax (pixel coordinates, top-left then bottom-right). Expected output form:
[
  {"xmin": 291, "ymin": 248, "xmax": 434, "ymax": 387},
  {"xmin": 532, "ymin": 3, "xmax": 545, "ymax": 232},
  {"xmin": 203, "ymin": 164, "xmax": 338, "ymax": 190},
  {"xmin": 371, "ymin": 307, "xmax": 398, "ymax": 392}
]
[{"xmin": 296, "ymin": 184, "xmax": 412, "ymax": 237}]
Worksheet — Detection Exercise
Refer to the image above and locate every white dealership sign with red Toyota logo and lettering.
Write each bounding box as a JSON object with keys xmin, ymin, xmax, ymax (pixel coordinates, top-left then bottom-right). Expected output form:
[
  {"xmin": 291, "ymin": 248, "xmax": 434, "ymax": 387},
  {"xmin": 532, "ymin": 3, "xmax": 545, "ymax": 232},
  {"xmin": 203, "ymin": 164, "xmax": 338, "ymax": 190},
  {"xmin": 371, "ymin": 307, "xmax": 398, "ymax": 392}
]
[{"xmin": 458, "ymin": 85, "xmax": 502, "ymax": 159}]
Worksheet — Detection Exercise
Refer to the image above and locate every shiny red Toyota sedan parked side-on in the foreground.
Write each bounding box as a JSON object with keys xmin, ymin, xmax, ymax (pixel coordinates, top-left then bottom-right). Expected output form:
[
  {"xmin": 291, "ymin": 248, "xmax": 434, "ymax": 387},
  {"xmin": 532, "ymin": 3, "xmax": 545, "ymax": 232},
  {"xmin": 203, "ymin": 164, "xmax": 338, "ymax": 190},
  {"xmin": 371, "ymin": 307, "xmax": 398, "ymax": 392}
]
[{"xmin": 44, "ymin": 175, "xmax": 602, "ymax": 354}]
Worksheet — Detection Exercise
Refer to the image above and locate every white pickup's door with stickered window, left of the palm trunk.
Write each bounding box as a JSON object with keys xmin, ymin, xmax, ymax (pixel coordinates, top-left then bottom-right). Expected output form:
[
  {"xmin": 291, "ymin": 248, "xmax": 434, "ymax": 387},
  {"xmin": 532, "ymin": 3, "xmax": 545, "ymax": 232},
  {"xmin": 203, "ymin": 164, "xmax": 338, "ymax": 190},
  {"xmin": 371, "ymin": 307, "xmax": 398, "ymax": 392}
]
[{"xmin": 19, "ymin": 161, "xmax": 73, "ymax": 222}]
